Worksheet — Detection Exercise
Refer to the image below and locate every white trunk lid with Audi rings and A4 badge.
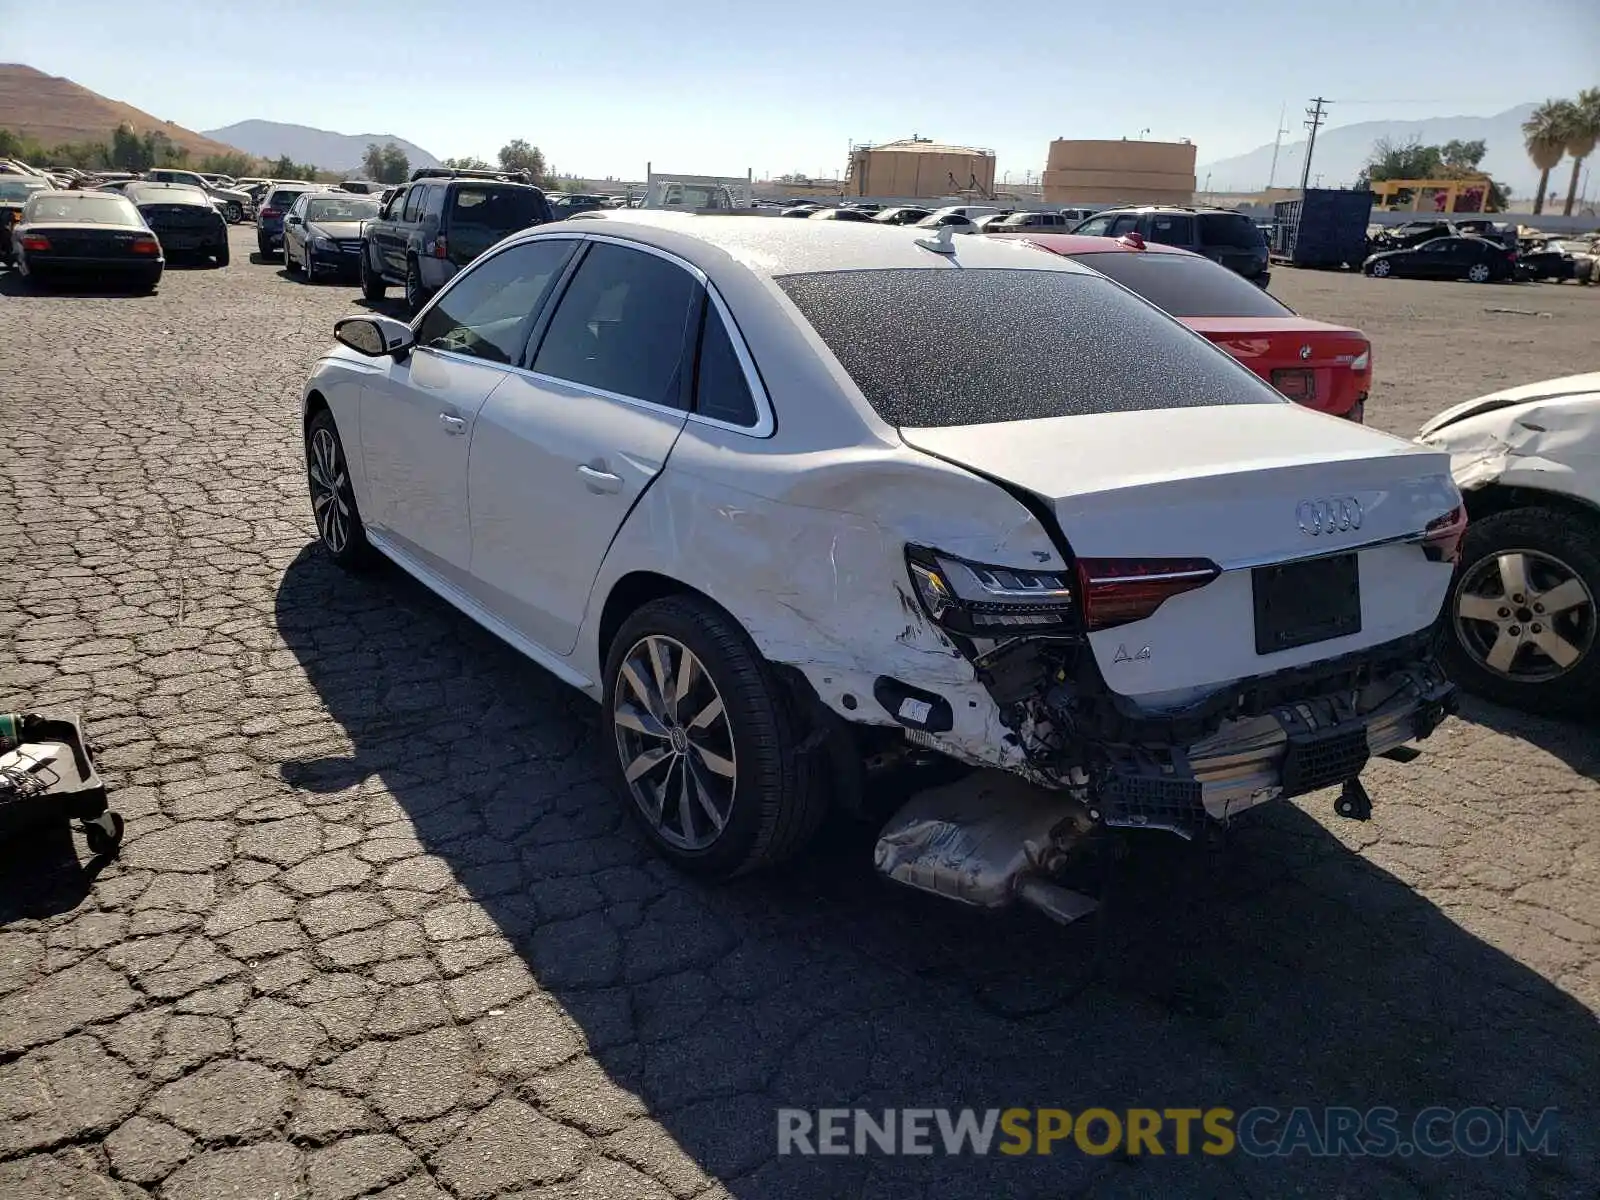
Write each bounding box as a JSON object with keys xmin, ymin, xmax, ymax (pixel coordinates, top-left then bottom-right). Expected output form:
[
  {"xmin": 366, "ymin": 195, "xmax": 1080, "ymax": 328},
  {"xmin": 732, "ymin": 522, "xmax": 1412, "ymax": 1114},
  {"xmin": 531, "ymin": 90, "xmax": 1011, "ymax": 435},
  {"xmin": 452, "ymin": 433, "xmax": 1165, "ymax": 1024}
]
[{"xmin": 901, "ymin": 403, "xmax": 1461, "ymax": 707}]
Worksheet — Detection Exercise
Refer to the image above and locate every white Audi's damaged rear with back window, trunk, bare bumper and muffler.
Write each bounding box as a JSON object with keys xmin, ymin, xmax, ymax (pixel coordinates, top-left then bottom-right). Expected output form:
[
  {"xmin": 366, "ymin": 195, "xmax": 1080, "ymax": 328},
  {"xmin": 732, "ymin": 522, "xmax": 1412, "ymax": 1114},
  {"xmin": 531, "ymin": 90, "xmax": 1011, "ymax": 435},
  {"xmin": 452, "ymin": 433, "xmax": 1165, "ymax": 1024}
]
[{"xmin": 779, "ymin": 260, "xmax": 1466, "ymax": 920}]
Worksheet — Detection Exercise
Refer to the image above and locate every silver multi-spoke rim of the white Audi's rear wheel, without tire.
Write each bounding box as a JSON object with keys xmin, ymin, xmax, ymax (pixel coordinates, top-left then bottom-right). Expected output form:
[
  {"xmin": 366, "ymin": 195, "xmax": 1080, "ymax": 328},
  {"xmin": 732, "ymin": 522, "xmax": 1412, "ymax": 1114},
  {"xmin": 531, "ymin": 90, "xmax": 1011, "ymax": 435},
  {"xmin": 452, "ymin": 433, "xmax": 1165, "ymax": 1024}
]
[{"xmin": 611, "ymin": 634, "xmax": 739, "ymax": 850}]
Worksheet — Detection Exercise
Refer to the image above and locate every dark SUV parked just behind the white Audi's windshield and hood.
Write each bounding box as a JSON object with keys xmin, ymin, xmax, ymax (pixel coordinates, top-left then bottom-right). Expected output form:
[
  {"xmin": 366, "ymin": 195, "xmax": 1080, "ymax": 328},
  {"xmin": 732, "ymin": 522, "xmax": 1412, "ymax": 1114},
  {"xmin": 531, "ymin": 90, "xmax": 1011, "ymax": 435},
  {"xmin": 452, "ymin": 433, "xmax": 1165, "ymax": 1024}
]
[{"xmin": 360, "ymin": 168, "xmax": 555, "ymax": 312}]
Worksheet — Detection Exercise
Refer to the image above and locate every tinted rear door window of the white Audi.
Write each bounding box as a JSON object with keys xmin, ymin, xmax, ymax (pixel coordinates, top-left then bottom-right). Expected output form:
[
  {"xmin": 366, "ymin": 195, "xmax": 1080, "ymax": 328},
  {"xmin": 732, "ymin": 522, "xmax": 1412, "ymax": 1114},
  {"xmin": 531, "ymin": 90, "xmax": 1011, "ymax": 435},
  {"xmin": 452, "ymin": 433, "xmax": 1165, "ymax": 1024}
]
[{"xmin": 533, "ymin": 242, "xmax": 699, "ymax": 408}]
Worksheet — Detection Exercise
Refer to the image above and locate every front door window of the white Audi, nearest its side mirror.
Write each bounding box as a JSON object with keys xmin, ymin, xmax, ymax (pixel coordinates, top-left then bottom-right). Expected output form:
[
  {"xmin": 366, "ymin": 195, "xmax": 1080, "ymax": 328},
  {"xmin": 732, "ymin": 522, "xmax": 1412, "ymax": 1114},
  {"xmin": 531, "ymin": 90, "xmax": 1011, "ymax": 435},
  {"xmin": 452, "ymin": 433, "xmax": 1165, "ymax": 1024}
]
[{"xmin": 416, "ymin": 238, "xmax": 576, "ymax": 365}]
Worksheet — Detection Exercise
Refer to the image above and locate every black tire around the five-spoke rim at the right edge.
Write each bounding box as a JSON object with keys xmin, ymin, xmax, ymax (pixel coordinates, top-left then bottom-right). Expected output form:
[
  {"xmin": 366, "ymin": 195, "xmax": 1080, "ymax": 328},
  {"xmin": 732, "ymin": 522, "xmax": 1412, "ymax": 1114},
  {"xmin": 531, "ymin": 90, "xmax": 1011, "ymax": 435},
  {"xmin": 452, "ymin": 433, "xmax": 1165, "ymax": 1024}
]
[{"xmin": 1443, "ymin": 507, "xmax": 1600, "ymax": 714}]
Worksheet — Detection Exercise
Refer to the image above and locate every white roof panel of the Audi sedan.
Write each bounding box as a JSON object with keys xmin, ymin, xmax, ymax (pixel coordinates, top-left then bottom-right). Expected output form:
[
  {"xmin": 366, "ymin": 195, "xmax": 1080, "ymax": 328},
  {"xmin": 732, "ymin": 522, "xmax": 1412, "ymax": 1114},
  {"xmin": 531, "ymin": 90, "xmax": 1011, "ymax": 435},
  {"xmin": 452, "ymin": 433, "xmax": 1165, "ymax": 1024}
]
[{"xmin": 518, "ymin": 208, "xmax": 1088, "ymax": 278}]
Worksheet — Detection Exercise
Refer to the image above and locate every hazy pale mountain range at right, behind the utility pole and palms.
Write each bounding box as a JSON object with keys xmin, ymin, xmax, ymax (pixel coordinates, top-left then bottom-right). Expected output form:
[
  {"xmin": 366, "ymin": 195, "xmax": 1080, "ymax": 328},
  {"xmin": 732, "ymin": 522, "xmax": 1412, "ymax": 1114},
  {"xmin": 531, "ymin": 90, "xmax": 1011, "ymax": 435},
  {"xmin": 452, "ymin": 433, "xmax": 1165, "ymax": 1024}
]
[{"xmin": 1195, "ymin": 104, "xmax": 1548, "ymax": 195}]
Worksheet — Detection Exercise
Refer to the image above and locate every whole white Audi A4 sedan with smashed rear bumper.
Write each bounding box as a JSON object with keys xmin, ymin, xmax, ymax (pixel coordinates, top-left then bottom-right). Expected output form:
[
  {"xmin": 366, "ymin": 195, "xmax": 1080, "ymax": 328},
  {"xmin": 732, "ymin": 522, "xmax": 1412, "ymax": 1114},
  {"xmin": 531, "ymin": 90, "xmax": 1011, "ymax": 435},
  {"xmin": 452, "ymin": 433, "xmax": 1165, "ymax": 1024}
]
[{"xmin": 304, "ymin": 211, "xmax": 1466, "ymax": 918}]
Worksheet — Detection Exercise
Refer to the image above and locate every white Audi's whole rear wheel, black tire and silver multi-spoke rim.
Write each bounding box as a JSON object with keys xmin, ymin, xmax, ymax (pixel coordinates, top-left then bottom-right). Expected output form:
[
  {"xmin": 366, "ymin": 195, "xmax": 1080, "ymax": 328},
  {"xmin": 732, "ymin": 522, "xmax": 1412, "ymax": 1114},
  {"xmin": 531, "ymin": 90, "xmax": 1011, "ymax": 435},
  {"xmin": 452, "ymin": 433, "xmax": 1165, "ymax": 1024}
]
[{"xmin": 603, "ymin": 595, "xmax": 824, "ymax": 878}]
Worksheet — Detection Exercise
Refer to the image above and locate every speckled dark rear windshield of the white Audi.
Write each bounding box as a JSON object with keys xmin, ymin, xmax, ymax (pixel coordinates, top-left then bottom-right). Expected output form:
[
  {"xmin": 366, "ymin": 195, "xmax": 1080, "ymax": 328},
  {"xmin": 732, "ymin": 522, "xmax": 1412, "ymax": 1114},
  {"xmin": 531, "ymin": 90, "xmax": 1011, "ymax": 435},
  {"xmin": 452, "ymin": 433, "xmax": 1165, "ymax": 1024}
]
[{"xmin": 778, "ymin": 267, "xmax": 1288, "ymax": 427}]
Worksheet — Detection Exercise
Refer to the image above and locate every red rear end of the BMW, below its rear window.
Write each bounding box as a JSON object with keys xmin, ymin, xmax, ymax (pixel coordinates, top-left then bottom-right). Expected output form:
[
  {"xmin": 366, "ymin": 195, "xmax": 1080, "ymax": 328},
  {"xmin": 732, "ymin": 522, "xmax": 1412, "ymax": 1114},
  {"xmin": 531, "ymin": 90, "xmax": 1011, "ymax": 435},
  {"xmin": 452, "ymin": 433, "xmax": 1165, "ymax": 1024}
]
[{"xmin": 1182, "ymin": 317, "xmax": 1371, "ymax": 414}]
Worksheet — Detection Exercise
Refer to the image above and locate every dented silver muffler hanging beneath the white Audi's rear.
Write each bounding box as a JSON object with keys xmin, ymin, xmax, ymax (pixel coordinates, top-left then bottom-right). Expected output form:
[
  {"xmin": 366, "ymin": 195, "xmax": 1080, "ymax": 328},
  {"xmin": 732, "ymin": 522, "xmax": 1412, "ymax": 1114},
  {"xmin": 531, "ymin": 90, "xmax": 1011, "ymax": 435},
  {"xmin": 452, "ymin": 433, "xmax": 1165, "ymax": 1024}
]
[{"xmin": 874, "ymin": 771, "xmax": 1099, "ymax": 925}]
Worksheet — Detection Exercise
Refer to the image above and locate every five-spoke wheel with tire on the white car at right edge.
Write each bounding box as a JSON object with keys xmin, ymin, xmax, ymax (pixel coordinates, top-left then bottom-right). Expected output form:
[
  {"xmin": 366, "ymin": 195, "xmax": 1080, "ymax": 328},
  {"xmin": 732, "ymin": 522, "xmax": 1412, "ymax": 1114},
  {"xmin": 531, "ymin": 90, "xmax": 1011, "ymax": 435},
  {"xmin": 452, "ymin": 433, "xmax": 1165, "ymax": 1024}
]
[{"xmin": 1445, "ymin": 509, "xmax": 1600, "ymax": 712}]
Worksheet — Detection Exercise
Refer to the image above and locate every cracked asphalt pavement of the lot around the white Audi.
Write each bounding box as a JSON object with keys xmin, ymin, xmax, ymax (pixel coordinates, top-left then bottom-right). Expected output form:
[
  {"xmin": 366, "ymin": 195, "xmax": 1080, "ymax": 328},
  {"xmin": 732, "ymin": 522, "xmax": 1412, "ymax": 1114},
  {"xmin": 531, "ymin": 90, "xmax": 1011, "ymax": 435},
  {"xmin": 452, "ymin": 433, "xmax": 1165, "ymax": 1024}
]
[{"xmin": 0, "ymin": 229, "xmax": 1600, "ymax": 1200}]
